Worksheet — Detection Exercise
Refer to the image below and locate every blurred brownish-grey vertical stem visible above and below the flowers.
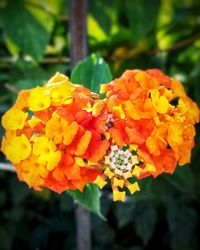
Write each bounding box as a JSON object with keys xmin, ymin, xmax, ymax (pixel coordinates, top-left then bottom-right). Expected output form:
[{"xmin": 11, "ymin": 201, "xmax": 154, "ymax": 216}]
[{"xmin": 69, "ymin": 0, "xmax": 91, "ymax": 250}]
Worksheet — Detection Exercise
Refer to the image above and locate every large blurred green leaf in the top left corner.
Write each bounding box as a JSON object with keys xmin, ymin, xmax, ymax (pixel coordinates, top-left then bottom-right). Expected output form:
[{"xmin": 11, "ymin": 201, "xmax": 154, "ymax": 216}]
[{"xmin": 0, "ymin": 1, "xmax": 53, "ymax": 60}]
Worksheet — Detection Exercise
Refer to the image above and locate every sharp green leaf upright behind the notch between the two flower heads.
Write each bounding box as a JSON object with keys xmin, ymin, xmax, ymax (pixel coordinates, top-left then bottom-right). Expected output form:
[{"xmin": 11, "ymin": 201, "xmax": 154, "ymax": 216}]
[{"xmin": 71, "ymin": 53, "xmax": 112, "ymax": 93}]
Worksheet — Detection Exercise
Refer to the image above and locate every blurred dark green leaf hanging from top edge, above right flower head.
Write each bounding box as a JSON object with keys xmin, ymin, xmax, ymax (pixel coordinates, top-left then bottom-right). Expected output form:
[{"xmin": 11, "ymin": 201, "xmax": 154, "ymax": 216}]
[{"xmin": 125, "ymin": 0, "xmax": 160, "ymax": 44}]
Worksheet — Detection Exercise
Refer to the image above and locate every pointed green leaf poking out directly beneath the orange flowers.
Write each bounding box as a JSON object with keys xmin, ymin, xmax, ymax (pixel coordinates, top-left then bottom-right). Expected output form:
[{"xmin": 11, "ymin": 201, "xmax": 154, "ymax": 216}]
[{"xmin": 67, "ymin": 184, "xmax": 105, "ymax": 220}]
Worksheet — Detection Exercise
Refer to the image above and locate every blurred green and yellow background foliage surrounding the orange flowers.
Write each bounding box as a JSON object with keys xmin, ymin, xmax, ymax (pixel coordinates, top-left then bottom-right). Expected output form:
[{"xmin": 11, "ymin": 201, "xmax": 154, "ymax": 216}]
[{"xmin": 0, "ymin": 0, "xmax": 200, "ymax": 250}]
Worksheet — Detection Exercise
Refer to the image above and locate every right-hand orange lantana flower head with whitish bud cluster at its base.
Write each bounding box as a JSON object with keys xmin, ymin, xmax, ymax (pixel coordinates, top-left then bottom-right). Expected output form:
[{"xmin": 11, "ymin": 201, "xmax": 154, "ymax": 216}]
[{"xmin": 95, "ymin": 69, "xmax": 199, "ymax": 201}]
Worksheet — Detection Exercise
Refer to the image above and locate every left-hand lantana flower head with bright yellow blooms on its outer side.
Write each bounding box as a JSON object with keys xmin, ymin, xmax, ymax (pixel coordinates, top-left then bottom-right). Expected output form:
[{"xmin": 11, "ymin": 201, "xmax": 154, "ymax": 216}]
[{"xmin": 1, "ymin": 73, "xmax": 109, "ymax": 192}]
